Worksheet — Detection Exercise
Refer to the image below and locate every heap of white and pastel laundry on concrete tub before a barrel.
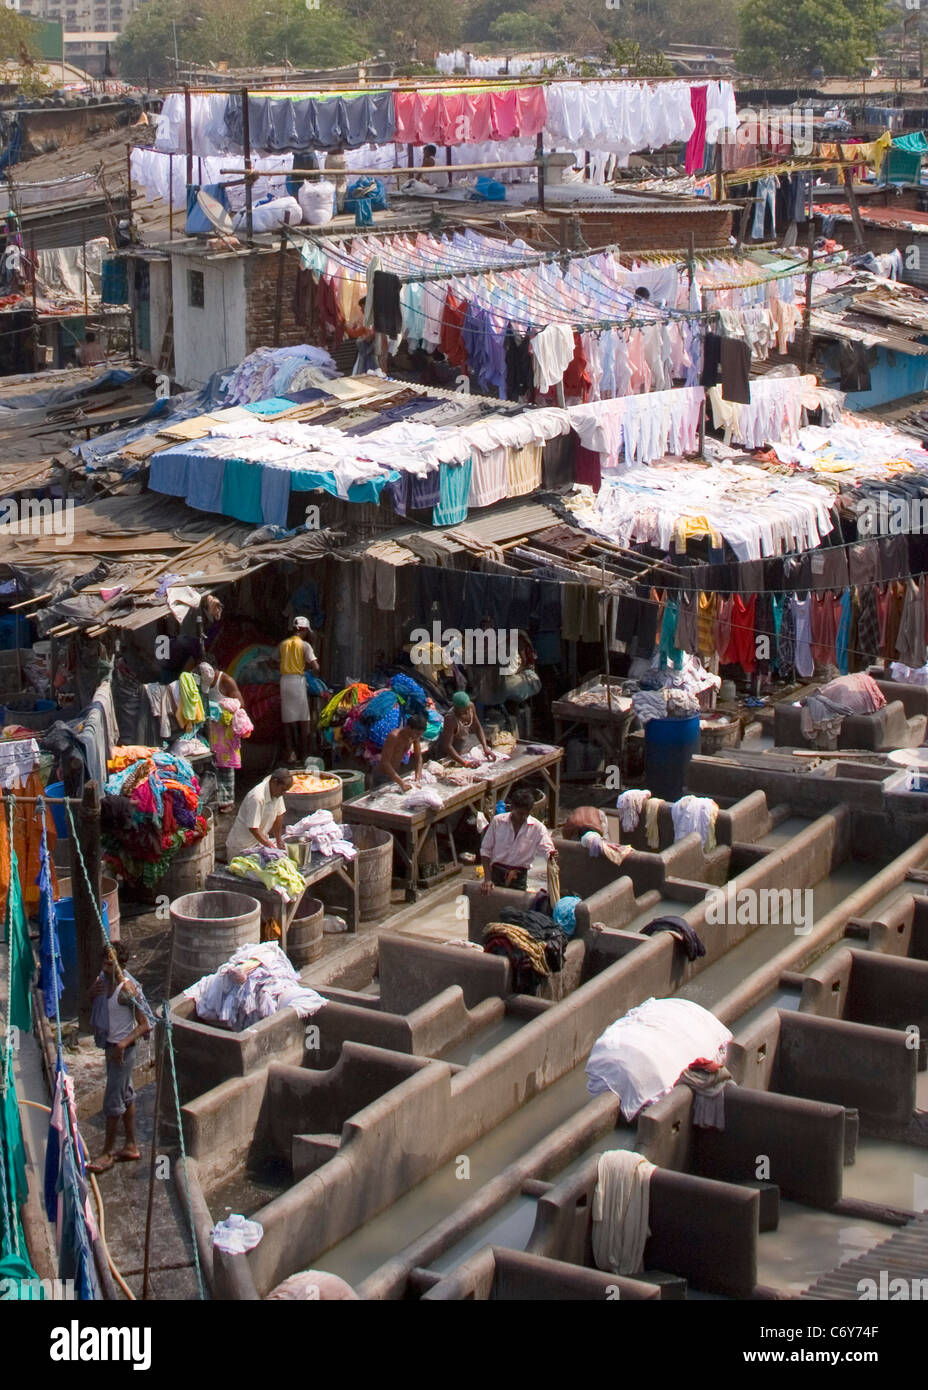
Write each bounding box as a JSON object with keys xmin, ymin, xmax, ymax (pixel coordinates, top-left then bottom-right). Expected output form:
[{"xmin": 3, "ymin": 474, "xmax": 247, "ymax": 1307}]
[{"xmin": 183, "ymin": 941, "xmax": 328, "ymax": 1033}]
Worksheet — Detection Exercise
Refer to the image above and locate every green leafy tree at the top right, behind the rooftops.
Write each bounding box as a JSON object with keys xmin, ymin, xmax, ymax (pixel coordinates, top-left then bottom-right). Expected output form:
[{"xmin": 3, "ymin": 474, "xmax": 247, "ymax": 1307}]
[{"xmin": 738, "ymin": 0, "xmax": 890, "ymax": 78}]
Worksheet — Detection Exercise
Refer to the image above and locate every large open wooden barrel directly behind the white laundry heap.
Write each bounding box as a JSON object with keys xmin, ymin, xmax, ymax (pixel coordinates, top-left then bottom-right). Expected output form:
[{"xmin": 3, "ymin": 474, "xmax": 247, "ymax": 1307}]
[{"xmin": 171, "ymin": 892, "xmax": 261, "ymax": 992}]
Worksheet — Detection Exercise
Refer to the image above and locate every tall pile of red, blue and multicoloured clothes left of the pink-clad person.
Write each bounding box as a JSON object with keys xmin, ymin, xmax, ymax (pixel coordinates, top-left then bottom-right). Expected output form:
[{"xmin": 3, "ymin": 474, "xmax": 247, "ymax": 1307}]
[{"xmin": 100, "ymin": 748, "xmax": 210, "ymax": 888}]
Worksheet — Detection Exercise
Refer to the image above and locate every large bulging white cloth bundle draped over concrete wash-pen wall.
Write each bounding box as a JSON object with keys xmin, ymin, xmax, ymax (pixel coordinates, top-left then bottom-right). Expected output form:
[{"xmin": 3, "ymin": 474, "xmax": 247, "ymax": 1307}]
[{"xmin": 586, "ymin": 999, "xmax": 732, "ymax": 1120}]
